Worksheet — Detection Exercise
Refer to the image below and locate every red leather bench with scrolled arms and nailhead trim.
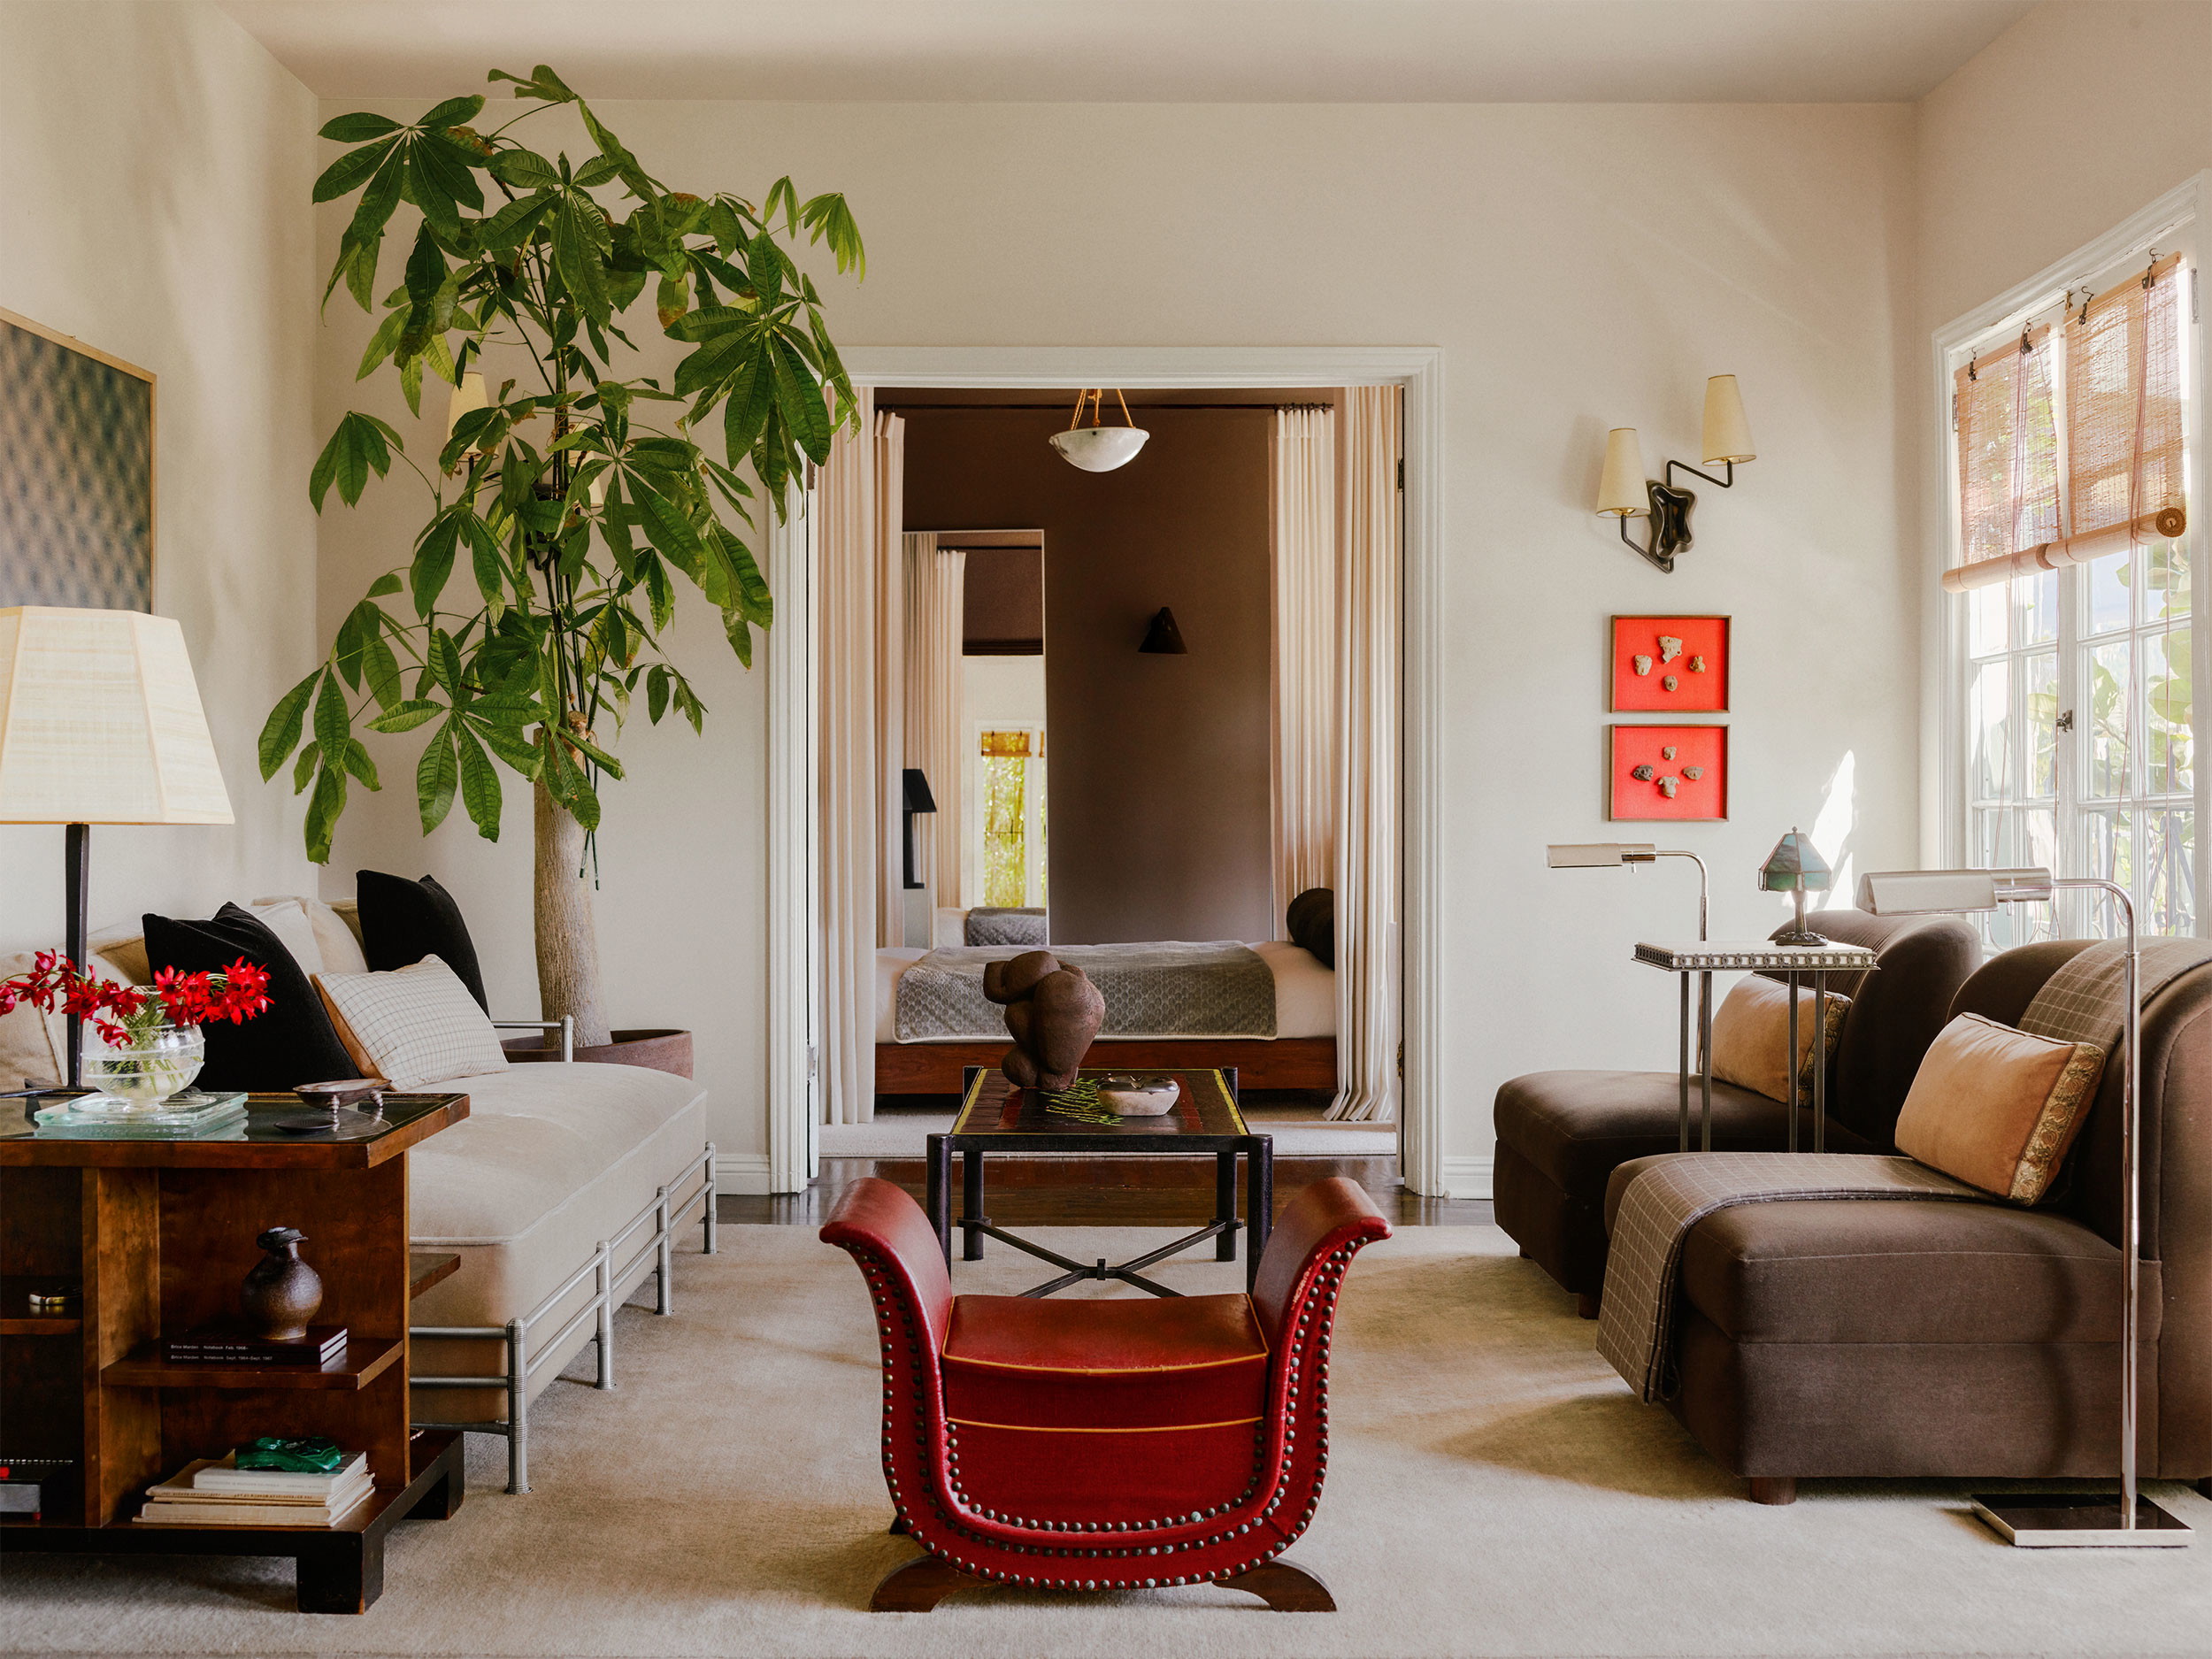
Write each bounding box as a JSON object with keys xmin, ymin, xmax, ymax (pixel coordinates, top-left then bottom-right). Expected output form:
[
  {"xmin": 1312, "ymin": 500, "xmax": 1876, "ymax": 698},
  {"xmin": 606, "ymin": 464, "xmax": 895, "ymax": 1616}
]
[{"xmin": 821, "ymin": 1177, "xmax": 1389, "ymax": 1613}]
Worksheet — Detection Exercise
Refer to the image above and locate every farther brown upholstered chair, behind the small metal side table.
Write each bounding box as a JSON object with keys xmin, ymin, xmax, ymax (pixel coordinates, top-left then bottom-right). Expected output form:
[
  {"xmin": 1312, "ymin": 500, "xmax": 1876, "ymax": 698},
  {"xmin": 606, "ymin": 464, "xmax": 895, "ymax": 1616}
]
[{"xmin": 1494, "ymin": 910, "xmax": 1982, "ymax": 1317}]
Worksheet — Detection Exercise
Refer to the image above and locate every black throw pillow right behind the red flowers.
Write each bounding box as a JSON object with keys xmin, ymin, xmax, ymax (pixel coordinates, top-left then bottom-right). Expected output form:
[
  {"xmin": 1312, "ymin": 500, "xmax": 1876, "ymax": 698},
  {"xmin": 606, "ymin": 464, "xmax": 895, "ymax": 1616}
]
[{"xmin": 144, "ymin": 905, "xmax": 361, "ymax": 1093}]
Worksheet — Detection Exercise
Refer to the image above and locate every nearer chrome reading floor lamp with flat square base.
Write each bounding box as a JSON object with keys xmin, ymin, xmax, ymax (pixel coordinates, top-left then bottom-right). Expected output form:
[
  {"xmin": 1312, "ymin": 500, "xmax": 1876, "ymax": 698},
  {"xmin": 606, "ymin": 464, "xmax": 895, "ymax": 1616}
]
[{"xmin": 1858, "ymin": 870, "xmax": 2190, "ymax": 1548}]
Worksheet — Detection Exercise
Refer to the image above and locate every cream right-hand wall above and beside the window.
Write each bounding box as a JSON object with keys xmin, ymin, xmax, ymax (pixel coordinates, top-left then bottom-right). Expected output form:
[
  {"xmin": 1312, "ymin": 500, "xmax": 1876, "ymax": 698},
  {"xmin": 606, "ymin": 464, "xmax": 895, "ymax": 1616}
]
[{"xmin": 1907, "ymin": 0, "xmax": 2212, "ymax": 863}]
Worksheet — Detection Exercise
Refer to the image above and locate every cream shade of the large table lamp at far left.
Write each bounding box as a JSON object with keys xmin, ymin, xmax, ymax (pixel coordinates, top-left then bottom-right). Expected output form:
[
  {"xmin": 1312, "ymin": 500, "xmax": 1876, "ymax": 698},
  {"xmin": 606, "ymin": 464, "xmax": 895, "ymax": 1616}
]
[{"xmin": 0, "ymin": 606, "xmax": 230, "ymax": 823}]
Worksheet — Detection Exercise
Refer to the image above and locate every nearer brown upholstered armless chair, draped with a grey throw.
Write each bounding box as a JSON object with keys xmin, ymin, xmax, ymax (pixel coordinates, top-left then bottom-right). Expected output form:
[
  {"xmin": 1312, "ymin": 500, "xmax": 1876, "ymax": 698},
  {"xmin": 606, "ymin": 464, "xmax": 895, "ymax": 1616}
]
[{"xmin": 1606, "ymin": 941, "xmax": 2212, "ymax": 1502}]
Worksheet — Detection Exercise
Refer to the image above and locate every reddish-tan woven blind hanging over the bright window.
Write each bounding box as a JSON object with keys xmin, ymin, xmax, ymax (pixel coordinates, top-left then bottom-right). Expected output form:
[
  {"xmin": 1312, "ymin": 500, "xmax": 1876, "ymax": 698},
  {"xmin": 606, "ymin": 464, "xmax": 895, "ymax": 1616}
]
[{"xmin": 1942, "ymin": 255, "xmax": 2188, "ymax": 593}]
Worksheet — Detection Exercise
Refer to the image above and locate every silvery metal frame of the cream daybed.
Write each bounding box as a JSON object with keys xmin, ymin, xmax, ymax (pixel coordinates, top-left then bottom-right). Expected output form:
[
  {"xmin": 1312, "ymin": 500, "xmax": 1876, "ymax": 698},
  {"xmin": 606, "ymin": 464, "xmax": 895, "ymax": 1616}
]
[{"xmin": 407, "ymin": 1020, "xmax": 717, "ymax": 1494}]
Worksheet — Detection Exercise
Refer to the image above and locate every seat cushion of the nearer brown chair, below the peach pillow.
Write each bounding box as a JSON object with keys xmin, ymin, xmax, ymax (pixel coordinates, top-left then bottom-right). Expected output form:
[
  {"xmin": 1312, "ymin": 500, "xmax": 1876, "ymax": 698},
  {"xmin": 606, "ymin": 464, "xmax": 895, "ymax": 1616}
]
[{"xmin": 1681, "ymin": 1199, "xmax": 2159, "ymax": 1343}]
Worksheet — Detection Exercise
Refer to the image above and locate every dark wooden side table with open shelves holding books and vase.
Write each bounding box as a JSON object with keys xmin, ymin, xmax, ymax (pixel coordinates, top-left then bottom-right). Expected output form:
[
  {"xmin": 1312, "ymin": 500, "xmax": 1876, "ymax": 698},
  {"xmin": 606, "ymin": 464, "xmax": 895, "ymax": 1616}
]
[{"xmin": 0, "ymin": 1095, "xmax": 469, "ymax": 1613}]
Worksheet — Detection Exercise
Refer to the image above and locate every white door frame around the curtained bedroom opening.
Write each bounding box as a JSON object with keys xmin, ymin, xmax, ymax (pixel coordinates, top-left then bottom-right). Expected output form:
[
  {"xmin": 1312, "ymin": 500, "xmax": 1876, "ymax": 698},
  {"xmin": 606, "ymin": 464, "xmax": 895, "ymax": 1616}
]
[{"xmin": 768, "ymin": 345, "xmax": 1447, "ymax": 1197}]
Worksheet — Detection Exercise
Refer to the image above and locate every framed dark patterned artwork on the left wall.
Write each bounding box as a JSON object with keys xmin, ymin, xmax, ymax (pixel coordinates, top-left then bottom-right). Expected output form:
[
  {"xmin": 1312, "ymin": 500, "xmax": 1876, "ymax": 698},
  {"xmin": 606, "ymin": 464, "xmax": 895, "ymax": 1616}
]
[{"xmin": 0, "ymin": 310, "xmax": 155, "ymax": 611}]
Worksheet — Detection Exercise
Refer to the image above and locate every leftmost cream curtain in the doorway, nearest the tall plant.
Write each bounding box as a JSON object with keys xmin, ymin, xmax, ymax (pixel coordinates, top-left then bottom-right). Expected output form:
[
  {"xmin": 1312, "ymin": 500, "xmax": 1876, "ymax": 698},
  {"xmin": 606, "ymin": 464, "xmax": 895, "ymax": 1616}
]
[{"xmin": 814, "ymin": 389, "xmax": 880, "ymax": 1124}]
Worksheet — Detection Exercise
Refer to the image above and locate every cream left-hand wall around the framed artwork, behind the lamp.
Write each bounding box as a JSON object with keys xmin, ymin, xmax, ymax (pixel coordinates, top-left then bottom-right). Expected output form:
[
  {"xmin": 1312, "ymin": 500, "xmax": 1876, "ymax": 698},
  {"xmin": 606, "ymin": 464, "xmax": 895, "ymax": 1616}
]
[{"xmin": 0, "ymin": 0, "xmax": 321, "ymax": 951}]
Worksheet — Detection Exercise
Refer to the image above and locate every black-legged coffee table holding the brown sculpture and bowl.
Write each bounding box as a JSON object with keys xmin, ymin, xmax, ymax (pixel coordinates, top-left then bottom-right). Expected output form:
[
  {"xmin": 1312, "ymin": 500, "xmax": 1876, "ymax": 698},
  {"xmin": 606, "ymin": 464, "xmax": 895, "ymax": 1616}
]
[{"xmin": 929, "ymin": 1069, "xmax": 1274, "ymax": 1296}]
